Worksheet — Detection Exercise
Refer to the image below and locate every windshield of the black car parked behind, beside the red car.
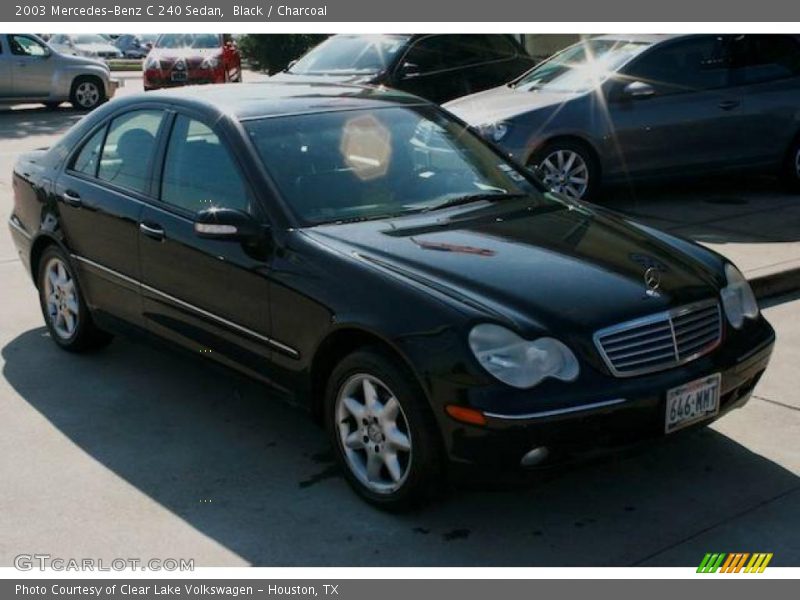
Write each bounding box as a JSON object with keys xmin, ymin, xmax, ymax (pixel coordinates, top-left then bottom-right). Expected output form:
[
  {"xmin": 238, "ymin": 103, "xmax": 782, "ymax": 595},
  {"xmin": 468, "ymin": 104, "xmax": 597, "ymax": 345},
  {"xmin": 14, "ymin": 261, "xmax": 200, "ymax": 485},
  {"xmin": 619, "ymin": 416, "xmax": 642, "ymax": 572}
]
[{"xmin": 289, "ymin": 35, "xmax": 409, "ymax": 75}]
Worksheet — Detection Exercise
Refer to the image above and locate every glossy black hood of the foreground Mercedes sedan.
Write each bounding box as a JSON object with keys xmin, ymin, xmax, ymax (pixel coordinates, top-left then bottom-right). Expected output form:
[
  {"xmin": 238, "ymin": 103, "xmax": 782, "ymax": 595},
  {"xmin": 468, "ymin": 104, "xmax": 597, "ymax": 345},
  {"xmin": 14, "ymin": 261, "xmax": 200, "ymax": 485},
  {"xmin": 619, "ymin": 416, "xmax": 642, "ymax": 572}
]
[{"xmin": 304, "ymin": 199, "xmax": 721, "ymax": 332}]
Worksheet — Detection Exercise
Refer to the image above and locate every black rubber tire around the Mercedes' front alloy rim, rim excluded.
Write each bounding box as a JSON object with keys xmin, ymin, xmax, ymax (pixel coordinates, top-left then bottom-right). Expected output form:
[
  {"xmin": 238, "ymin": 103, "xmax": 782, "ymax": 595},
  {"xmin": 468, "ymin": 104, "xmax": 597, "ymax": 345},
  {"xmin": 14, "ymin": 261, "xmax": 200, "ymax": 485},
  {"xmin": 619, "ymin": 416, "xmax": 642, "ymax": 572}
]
[{"xmin": 325, "ymin": 349, "xmax": 444, "ymax": 511}]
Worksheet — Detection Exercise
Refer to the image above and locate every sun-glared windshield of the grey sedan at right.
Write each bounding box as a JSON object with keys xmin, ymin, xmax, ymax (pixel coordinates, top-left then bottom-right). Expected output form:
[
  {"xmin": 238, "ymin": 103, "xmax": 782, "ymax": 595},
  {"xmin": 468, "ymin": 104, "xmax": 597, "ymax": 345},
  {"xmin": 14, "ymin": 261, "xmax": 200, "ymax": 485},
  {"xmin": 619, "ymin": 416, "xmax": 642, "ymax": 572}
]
[{"xmin": 514, "ymin": 39, "xmax": 649, "ymax": 92}]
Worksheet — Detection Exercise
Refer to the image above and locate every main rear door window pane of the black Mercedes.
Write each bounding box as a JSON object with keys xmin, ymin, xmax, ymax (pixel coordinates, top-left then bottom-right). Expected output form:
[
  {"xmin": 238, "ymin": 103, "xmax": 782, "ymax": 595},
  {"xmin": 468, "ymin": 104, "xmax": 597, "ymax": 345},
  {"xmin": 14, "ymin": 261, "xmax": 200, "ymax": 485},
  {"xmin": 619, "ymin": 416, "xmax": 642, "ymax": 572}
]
[{"xmin": 97, "ymin": 110, "xmax": 164, "ymax": 194}]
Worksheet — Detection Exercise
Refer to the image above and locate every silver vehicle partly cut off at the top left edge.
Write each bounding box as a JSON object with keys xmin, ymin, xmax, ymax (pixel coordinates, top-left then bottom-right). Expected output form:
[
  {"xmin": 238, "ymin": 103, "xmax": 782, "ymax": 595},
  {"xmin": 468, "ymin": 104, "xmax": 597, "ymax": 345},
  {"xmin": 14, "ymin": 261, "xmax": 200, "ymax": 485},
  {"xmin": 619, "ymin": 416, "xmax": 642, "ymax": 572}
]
[{"xmin": 0, "ymin": 33, "xmax": 119, "ymax": 110}]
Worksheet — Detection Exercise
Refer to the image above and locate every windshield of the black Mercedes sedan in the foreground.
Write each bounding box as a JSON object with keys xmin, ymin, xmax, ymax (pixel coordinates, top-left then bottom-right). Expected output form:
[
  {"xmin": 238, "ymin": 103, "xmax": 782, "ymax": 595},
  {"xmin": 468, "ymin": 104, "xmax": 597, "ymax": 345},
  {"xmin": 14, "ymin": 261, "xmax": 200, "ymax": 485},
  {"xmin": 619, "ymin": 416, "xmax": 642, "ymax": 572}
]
[{"xmin": 245, "ymin": 106, "xmax": 545, "ymax": 225}]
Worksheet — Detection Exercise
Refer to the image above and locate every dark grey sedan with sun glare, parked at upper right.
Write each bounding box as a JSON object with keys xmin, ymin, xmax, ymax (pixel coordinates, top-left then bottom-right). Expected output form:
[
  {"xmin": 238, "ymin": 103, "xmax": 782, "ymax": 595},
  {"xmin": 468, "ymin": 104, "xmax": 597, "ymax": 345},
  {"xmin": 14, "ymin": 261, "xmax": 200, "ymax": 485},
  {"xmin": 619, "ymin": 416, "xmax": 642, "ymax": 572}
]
[{"xmin": 446, "ymin": 35, "xmax": 800, "ymax": 198}]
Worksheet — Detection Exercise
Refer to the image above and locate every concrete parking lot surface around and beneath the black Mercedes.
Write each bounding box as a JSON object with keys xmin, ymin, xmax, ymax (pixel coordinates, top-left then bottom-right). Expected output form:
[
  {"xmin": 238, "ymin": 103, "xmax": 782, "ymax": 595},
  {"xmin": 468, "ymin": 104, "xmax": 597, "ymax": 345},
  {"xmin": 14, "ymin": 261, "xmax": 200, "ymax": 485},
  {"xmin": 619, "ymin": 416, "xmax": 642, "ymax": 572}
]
[{"xmin": 0, "ymin": 74, "xmax": 800, "ymax": 566}]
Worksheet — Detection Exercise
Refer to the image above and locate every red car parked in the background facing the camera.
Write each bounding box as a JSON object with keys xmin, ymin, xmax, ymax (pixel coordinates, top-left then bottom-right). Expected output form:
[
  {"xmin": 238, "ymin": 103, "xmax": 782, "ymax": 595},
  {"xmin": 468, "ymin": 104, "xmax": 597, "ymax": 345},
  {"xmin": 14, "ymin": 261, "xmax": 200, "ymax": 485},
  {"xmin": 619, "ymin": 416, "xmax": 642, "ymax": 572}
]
[{"xmin": 143, "ymin": 33, "xmax": 242, "ymax": 90}]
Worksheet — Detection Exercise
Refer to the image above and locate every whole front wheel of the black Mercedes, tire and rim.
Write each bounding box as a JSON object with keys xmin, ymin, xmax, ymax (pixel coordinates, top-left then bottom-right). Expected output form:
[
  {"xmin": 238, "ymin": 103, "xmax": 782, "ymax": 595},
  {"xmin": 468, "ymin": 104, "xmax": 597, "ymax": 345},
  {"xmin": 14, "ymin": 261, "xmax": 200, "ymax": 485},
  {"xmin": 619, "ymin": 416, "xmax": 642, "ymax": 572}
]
[{"xmin": 325, "ymin": 348, "xmax": 445, "ymax": 512}]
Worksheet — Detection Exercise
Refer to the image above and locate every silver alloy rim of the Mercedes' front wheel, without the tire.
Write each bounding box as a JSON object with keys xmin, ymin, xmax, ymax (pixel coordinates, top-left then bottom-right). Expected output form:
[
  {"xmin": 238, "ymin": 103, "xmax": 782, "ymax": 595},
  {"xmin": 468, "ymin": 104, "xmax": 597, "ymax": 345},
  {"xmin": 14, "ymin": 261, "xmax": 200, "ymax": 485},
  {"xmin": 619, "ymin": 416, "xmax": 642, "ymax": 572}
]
[{"xmin": 334, "ymin": 373, "xmax": 411, "ymax": 494}]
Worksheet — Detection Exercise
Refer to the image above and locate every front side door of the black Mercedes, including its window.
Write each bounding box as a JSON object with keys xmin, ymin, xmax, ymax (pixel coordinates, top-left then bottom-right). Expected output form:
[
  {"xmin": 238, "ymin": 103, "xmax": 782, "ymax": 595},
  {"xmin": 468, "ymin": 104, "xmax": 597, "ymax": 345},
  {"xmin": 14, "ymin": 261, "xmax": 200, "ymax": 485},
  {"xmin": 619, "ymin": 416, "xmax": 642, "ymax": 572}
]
[{"xmin": 139, "ymin": 113, "xmax": 272, "ymax": 376}]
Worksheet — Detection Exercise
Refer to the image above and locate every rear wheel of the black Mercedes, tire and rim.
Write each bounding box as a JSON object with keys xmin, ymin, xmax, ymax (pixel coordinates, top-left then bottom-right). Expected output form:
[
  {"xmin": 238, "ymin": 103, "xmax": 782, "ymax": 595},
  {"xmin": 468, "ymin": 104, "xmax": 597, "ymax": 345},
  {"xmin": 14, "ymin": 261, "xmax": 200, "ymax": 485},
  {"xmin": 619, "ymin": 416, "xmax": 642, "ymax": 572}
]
[{"xmin": 36, "ymin": 246, "xmax": 113, "ymax": 352}]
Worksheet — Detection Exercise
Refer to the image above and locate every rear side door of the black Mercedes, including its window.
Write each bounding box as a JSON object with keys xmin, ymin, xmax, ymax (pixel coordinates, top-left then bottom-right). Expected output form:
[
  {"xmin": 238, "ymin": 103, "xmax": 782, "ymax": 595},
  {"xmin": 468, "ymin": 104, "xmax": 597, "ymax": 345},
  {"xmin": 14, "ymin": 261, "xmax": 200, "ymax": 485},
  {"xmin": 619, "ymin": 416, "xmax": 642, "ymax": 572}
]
[{"xmin": 55, "ymin": 106, "xmax": 165, "ymax": 325}]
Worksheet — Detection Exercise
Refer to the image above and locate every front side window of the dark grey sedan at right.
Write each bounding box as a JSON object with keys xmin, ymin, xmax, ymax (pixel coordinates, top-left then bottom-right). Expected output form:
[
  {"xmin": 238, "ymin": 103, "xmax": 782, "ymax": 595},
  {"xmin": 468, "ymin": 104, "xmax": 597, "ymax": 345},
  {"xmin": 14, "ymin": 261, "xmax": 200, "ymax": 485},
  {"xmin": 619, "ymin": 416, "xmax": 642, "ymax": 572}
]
[{"xmin": 625, "ymin": 36, "xmax": 729, "ymax": 94}]
